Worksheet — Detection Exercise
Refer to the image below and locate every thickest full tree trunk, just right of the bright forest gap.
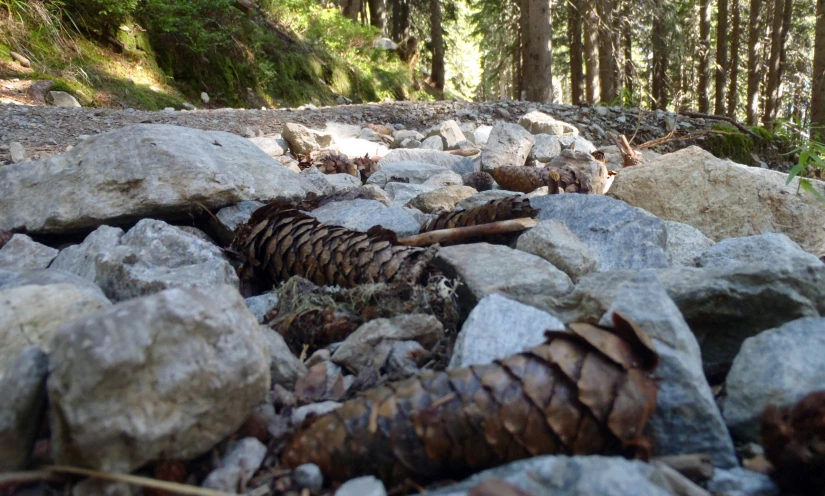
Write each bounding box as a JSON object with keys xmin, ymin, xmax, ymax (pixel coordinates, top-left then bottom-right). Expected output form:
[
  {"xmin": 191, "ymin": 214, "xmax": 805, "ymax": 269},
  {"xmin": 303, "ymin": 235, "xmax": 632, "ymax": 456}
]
[{"xmin": 522, "ymin": 0, "xmax": 553, "ymax": 103}]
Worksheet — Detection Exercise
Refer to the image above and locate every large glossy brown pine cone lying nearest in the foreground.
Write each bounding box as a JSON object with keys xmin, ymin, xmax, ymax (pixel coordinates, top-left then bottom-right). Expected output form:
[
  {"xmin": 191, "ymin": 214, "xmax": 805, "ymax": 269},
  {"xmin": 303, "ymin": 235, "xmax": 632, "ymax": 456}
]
[{"xmin": 281, "ymin": 314, "xmax": 658, "ymax": 484}]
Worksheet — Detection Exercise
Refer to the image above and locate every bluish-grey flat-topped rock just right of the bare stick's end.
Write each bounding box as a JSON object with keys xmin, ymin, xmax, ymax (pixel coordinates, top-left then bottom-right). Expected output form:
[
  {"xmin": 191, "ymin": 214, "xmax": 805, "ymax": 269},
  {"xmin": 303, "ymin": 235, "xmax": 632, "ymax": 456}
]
[{"xmin": 530, "ymin": 195, "xmax": 670, "ymax": 271}]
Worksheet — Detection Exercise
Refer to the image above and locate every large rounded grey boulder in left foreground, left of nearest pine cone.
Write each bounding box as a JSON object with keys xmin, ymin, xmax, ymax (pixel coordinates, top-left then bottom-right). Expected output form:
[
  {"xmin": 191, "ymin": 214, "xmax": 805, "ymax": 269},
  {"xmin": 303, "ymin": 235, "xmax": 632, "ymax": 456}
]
[{"xmin": 48, "ymin": 285, "xmax": 270, "ymax": 473}]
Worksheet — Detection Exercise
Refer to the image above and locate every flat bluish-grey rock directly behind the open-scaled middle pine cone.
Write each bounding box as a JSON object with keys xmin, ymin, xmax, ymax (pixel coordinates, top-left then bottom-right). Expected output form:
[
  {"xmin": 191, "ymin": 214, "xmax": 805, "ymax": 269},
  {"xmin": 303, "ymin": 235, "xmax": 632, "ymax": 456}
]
[{"xmin": 310, "ymin": 200, "xmax": 421, "ymax": 236}]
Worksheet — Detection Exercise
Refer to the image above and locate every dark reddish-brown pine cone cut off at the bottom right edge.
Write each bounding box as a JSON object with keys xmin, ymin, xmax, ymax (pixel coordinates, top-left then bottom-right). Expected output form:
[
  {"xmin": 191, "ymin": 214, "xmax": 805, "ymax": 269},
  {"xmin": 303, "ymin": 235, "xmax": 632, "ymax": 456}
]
[{"xmin": 762, "ymin": 390, "xmax": 825, "ymax": 496}]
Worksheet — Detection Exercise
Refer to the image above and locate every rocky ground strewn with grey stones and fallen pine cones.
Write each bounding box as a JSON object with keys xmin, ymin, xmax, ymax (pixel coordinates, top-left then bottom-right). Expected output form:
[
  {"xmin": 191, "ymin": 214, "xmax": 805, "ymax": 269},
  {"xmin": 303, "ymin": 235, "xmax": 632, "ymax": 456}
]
[{"xmin": 0, "ymin": 107, "xmax": 825, "ymax": 496}]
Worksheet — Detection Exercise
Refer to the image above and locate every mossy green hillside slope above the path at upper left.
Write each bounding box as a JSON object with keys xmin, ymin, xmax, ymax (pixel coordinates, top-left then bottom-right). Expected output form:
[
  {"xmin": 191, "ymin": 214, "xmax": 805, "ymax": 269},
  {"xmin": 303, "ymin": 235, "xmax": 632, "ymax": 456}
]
[{"xmin": 0, "ymin": 0, "xmax": 430, "ymax": 110}]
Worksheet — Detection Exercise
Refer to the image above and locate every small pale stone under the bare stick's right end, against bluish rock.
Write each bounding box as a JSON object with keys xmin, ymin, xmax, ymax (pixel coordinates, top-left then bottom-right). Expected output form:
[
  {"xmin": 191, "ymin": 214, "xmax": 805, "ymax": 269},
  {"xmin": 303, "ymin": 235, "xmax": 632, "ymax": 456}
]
[{"xmin": 516, "ymin": 220, "xmax": 600, "ymax": 282}]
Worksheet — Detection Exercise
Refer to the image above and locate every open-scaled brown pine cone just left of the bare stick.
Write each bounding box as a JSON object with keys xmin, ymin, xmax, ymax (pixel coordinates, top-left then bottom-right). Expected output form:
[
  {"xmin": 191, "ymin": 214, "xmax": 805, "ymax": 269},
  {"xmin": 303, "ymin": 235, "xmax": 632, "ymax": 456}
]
[{"xmin": 232, "ymin": 202, "xmax": 434, "ymax": 287}]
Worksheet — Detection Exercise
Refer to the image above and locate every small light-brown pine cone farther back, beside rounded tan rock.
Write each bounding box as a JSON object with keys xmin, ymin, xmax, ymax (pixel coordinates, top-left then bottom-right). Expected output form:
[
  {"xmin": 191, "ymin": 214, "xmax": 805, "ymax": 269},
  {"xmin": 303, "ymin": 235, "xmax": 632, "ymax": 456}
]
[{"xmin": 490, "ymin": 166, "xmax": 590, "ymax": 195}]
